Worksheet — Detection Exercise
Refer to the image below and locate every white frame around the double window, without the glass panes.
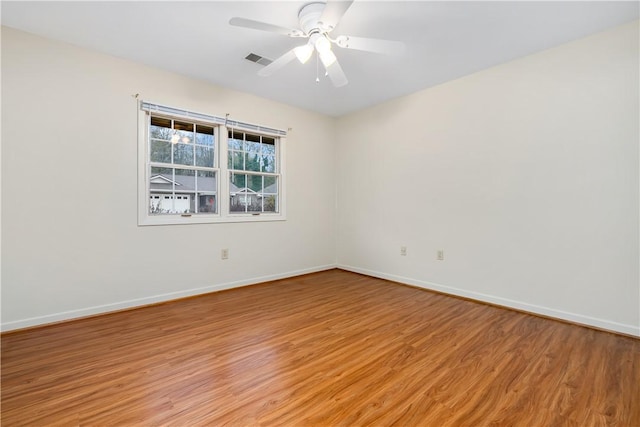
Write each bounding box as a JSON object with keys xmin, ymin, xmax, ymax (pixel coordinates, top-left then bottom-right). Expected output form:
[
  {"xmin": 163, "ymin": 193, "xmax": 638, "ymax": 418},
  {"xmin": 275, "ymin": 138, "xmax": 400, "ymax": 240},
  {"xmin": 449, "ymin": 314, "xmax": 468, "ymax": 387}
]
[{"xmin": 138, "ymin": 101, "xmax": 286, "ymax": 226}]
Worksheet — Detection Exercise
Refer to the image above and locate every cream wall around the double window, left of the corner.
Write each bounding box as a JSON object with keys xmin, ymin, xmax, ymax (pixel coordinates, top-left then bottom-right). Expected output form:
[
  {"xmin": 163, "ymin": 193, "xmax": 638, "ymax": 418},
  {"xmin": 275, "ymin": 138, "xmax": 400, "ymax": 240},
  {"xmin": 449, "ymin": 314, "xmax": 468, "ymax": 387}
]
[{"xmin": 2, "ymin": 28, "xmax": 336, "ymax": 330}]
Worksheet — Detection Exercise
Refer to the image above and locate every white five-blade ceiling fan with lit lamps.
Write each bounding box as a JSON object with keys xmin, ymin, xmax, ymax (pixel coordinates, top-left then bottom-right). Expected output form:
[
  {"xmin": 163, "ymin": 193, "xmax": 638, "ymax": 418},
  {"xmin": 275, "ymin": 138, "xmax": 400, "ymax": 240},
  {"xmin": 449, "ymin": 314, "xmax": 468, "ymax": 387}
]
[{"xmin": 229, "ymin": 0, "xmax": 404, "ymax": 87}]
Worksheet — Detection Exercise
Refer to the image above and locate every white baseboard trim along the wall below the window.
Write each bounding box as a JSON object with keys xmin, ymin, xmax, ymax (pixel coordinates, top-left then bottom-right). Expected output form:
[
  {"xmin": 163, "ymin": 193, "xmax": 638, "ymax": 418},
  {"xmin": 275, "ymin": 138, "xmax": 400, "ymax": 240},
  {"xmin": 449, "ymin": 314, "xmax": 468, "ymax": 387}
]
[{"xmin": 0, "ymin": 264, "xmax": 336, "ymax": 332}]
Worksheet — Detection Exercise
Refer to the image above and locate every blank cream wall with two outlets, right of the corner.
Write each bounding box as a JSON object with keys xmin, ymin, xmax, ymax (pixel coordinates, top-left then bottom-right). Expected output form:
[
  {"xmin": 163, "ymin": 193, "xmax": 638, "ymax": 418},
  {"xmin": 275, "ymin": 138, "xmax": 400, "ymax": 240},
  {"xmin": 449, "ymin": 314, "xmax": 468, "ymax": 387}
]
[{"xmin": 337, "ymin": 22, "xmax": 640, "ymax": 336}]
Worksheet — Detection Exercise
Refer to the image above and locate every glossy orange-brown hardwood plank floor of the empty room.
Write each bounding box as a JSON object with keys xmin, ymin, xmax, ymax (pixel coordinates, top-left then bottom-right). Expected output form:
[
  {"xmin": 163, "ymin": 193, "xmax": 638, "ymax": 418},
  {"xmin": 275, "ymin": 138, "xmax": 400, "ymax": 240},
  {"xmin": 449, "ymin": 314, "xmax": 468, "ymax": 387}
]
[{"xmin": 1, "ymin": 270, "xmax": 640, "ymax": 427}]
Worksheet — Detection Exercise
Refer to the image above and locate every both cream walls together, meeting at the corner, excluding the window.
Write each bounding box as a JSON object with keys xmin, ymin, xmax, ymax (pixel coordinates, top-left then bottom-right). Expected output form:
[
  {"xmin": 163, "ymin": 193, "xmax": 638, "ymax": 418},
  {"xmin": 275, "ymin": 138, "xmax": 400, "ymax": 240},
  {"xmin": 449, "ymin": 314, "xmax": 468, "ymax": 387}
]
[{"xmin": 2, "ymin": 22, "xmax": 640, "ymax": 336}]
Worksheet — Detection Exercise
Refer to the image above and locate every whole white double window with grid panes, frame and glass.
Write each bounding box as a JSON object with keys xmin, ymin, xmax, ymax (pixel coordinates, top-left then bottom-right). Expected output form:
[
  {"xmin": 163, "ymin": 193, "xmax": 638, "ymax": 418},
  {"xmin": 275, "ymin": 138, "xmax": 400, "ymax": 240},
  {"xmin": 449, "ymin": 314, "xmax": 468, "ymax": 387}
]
[{"xmin": 138, "ymin": 102, "xmax": 285, "ymax": 225}]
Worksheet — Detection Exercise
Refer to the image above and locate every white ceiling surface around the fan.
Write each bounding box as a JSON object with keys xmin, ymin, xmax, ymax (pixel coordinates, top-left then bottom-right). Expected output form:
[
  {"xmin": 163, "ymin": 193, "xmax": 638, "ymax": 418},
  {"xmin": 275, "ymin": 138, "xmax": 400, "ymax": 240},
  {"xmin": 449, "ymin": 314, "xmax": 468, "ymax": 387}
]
[{"xmin": 1, "ymin": 0, "xmax": 640, "ymax": 116}]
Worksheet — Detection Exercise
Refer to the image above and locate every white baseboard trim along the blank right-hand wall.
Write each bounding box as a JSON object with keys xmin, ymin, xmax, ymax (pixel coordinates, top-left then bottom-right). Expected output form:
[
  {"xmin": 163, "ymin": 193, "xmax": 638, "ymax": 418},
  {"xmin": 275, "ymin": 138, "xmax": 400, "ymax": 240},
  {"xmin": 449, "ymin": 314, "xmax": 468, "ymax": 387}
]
[{"xmin": 336, "ymin": 264, "xmax": 640, "ymax": 337}]
